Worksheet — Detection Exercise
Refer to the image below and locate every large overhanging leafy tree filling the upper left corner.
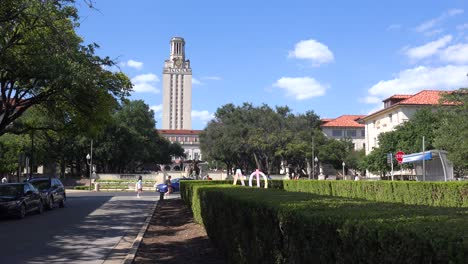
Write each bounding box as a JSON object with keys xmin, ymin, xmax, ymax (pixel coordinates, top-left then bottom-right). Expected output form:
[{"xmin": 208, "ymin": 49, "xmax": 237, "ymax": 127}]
[{"xmin": 0, "ymin": 0, "xmax": 132, "ymax": 135}]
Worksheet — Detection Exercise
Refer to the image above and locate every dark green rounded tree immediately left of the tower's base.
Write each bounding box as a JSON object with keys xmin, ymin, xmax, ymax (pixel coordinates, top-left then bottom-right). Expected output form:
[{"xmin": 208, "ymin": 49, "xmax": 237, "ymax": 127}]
[{"xmin": 95, "ymin": 100, "xmax": 184, "ymax": 172}]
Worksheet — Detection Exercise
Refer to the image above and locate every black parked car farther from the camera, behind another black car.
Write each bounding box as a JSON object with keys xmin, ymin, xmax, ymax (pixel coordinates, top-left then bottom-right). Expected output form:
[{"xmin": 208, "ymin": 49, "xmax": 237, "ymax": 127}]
[{"xmin": 28, "ymin": 178, "xmax": 67, "ymax": 209}]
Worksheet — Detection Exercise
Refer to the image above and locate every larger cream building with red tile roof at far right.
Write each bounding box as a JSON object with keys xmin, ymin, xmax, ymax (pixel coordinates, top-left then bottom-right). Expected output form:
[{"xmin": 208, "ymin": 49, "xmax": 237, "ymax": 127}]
[{"xmin": 363, "ymin": 90, "xmax": 446, "ymax": 155}]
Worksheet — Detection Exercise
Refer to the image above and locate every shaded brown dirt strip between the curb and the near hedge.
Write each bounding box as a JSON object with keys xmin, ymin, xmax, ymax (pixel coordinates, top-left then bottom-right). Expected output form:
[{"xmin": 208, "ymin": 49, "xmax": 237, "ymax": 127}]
[{"xmin": 133, "ymin": 195, "xmax": 226, "ymax": 264}]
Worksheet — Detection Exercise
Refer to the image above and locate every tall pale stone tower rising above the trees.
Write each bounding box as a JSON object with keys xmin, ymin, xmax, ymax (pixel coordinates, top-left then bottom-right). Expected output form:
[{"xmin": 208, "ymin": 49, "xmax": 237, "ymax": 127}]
[{"xmin": 162, "ymin": 37, "xmax": 192, "ymax": 130}]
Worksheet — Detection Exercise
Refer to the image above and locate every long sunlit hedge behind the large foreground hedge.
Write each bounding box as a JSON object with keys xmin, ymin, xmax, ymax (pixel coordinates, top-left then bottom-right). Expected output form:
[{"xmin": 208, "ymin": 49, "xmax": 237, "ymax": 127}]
[{"xmin": 283, "ymin": 180, "xmax": 468, "ymax": 207}]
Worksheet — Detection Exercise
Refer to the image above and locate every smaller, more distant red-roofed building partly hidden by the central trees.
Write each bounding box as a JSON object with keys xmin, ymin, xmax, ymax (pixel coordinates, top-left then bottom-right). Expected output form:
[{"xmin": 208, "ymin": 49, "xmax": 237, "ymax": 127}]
[{"xmin": 320, "ymin": 115, "xmax": 365, "ymax": 150}]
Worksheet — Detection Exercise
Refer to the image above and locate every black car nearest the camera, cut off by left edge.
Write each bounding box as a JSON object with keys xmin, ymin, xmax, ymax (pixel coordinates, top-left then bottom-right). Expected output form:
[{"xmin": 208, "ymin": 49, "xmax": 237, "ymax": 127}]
[{"xmin": 0, "ymin": 182, "xmax": 44, "ymax": 218}]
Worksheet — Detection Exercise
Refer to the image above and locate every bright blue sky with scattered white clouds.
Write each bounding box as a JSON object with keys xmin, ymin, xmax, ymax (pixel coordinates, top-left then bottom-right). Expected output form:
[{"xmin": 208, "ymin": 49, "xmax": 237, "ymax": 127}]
[{"xmin": 78, "ymin": 0, "xmax": 468, "ymax": 129}]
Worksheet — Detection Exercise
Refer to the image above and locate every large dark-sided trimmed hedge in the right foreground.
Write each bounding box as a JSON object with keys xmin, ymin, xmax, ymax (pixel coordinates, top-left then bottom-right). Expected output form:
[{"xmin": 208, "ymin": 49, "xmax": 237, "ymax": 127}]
[{"xmin": 186, "ymin": 184, "xmax": 468, "ymax": 263}]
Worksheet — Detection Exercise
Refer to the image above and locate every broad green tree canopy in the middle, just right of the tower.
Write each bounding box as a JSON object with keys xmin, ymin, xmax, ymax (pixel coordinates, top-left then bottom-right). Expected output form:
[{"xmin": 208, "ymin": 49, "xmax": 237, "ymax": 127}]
[{"xmin": 200, "ymin": 103, "xmax": 357, "ymax": 175}]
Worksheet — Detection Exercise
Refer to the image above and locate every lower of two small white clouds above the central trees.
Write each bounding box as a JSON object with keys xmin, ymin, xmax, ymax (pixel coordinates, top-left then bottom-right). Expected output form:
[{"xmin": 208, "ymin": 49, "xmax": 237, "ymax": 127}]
[{"xmin": 273, "ymin": 77, "xmax": 328, "ymax": 100}]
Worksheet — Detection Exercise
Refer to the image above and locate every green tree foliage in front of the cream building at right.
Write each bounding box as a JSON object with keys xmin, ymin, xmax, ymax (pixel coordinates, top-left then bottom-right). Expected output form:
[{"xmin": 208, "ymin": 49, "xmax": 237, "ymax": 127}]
[{"xmin": 362, "ymin": 88, "xmax": 468, "ymax": 176}]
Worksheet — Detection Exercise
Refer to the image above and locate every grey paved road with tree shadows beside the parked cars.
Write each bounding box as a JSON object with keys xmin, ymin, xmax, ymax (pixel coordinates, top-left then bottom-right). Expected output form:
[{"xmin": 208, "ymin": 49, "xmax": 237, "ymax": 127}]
[{"xmin": 0, "ymin": 192, "xmax": 159, "ymax": 264}]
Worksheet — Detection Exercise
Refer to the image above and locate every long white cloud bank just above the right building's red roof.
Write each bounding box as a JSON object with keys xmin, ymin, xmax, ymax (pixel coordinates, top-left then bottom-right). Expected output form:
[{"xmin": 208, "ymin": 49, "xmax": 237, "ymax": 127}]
[{"xmin": 368, "ymin": 65, "xmax": 468, "ymax": 99}]
